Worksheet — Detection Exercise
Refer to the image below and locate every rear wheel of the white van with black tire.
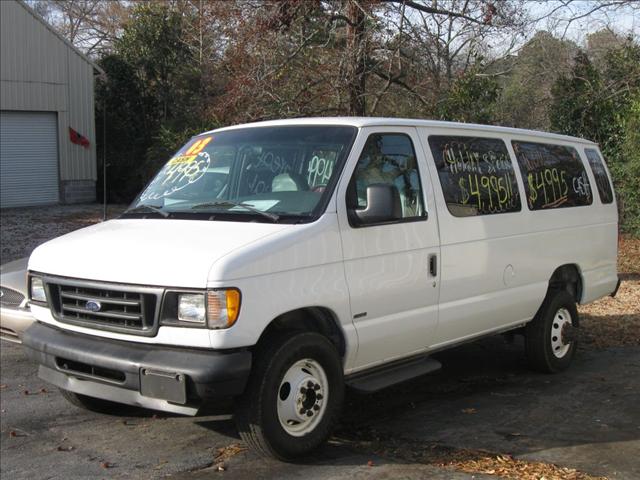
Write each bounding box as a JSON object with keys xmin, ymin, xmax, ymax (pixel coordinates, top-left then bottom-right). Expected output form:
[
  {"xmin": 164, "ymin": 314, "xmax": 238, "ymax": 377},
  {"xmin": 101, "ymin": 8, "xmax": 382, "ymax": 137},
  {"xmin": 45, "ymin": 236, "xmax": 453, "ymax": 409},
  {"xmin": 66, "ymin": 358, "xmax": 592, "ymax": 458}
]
[{"xmin": 525, "ymin": 290, "xmax": 578, "ymax": 373}]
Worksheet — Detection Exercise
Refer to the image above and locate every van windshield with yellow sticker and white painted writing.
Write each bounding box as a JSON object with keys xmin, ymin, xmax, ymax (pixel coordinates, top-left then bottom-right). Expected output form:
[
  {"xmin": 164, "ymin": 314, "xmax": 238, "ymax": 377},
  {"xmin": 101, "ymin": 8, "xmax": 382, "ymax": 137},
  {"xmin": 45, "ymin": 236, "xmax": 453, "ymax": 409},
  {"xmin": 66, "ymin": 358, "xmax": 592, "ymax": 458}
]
[{"xmin": 125, "ymin": 126, "xmax": 357, "ymax": 221}]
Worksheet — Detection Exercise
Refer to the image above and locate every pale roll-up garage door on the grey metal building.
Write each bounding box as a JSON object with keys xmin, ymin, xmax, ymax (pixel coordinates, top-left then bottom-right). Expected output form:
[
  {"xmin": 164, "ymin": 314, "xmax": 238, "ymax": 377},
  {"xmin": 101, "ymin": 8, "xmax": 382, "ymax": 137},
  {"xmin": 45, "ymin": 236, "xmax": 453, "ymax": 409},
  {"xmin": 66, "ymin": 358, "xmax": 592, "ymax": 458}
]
[{"xmin": 0, "ymin": 111, "xmax": 58, "ymax": 208}]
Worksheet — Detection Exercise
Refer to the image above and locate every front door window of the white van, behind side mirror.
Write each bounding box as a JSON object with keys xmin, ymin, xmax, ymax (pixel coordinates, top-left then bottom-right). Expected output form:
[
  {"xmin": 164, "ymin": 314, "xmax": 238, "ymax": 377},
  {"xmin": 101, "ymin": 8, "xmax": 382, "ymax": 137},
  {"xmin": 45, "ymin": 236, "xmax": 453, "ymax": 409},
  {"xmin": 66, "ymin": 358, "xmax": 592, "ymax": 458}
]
[{"xmin": 347, "ymin": 133, "xmax": 427, "ymax": 221}]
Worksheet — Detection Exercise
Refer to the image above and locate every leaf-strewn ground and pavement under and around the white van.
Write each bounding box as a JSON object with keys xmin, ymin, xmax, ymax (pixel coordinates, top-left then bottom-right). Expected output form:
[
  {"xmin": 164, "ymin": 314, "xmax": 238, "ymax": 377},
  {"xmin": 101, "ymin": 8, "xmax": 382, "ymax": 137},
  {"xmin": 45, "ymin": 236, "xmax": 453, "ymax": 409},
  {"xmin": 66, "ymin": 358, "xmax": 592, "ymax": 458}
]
[{"xmin": 0, "ymin": 205, "xmax": 640, "ymax": 480}]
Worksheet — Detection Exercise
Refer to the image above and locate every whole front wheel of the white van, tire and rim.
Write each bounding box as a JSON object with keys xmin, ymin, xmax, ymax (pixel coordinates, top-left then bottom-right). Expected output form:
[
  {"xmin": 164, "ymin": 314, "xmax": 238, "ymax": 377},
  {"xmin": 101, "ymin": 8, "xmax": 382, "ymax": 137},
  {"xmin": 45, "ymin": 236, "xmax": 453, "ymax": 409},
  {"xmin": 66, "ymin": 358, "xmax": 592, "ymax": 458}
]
[{"xmin": 235, "ymin": 333, "xmax": 344, "ymax": 460}]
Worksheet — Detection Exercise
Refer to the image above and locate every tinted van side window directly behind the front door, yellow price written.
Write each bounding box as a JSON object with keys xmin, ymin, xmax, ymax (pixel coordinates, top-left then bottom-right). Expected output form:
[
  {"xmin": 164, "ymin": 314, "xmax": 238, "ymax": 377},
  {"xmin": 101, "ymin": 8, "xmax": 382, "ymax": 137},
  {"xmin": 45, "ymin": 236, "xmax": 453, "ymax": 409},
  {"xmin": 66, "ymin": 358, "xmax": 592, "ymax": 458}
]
[{"xmin": 429, "ymin": 135, "xmax": 521, "ymax": 217}]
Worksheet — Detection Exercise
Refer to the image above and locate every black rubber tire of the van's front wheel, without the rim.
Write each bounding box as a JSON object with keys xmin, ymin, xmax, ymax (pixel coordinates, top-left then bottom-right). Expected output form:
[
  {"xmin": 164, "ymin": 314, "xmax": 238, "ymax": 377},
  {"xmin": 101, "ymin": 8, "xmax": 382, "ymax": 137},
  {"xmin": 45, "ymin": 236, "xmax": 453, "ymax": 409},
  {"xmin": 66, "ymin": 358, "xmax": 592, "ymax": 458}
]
[{"xmin": 235, "ymin": 332, "xmax": 344, "ymax": 461}]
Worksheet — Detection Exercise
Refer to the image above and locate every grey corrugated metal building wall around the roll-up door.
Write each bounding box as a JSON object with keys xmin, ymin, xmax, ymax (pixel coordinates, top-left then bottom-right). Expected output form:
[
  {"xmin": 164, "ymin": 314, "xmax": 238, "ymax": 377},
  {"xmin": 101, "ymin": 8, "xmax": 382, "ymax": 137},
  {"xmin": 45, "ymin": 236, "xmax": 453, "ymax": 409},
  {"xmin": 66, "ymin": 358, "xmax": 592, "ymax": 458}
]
[{"xmin": 0, "ymin": 0, "xmax": 96, "ymax": 180}]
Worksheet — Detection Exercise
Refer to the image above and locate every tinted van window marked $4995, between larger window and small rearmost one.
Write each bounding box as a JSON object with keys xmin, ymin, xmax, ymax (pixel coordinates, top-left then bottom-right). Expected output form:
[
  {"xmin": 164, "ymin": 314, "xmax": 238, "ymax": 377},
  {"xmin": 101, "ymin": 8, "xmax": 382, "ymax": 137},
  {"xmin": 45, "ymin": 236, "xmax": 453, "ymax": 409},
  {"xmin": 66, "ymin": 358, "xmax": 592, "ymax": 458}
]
[{"xmin": 511, "ymin": 141, "xmax": 593, "ymax": 210}]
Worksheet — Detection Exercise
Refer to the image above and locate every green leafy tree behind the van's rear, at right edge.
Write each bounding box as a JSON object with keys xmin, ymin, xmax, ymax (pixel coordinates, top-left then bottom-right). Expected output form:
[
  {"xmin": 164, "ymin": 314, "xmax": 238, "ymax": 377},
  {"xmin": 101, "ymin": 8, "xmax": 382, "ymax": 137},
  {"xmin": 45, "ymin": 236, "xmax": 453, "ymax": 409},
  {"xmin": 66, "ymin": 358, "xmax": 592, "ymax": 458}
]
[{"xmin": 551, "ymin": 40, "xmax": 640, "ymax": 235}]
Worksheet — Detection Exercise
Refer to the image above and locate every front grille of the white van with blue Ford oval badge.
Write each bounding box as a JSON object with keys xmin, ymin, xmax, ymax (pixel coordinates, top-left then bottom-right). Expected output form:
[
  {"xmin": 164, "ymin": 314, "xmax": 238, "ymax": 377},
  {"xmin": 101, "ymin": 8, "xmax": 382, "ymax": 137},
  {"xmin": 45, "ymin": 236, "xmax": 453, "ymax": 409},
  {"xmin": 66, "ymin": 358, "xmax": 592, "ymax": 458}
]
[{"xmin": 46, "ymin": 279, "xmax": 162, "ymax": 335}]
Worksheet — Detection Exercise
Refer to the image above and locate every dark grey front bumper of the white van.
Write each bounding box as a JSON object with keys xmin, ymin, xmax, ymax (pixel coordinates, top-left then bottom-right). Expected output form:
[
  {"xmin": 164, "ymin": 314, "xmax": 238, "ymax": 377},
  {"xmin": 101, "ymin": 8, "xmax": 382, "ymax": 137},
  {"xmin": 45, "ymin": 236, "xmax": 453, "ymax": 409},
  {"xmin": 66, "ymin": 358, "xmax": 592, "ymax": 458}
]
[{"xmin": 23, "ymin": 323, "xmax": 251, "ymax": 415}]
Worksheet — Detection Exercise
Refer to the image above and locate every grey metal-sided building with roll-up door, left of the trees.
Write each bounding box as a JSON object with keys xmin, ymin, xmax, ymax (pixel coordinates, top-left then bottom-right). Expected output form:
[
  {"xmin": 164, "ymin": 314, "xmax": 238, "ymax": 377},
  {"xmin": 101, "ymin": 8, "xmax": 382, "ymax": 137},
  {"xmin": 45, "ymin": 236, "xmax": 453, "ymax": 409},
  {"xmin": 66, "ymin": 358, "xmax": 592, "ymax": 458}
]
[{"xmin": 0, "ymin": 0, "xmax": 99, "ymax": 208}]
